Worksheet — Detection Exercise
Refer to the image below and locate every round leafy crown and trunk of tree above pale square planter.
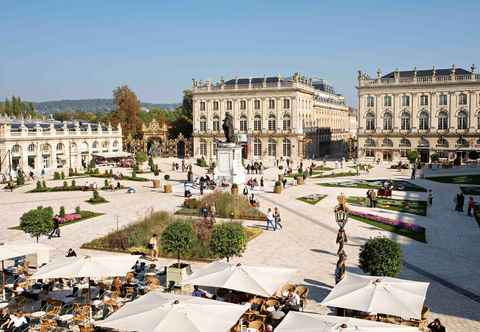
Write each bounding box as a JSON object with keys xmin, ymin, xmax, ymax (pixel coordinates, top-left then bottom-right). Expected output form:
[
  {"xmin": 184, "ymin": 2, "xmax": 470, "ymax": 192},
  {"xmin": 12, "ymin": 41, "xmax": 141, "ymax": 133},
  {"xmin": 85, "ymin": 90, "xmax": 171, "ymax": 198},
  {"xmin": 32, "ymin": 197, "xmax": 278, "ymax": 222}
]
[{"xmin": 160, "ymin": 221, "xmax": 195, "ymax": 267}]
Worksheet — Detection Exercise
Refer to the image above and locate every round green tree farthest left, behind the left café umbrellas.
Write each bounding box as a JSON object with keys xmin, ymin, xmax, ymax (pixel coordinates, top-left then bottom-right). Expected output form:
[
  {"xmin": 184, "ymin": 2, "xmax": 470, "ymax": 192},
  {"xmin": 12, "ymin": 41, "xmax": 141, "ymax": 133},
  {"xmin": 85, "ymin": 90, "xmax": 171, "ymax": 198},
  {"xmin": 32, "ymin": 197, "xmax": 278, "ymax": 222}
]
[{"xmin": 20, "ymin": 206, "xmax": 53, "ymax": 242}]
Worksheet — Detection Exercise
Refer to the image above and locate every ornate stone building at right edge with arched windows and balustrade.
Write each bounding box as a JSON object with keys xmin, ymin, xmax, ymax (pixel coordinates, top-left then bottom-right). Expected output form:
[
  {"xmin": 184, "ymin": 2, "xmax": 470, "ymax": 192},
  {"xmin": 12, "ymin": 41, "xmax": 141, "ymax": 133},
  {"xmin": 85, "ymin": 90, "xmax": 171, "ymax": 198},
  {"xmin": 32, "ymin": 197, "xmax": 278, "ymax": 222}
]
[{"xmin": 357, "ymin": 65, "xmax": 480, "ymax": 162}]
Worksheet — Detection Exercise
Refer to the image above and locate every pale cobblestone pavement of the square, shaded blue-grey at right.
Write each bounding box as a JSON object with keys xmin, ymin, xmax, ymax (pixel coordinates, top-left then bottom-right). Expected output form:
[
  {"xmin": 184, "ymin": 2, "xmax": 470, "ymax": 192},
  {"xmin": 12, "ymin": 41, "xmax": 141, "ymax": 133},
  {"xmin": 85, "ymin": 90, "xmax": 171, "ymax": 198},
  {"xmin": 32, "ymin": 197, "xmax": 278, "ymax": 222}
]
[{"xmin": 0, "ymin": 160, "xmax": 480, "ymax": 331}]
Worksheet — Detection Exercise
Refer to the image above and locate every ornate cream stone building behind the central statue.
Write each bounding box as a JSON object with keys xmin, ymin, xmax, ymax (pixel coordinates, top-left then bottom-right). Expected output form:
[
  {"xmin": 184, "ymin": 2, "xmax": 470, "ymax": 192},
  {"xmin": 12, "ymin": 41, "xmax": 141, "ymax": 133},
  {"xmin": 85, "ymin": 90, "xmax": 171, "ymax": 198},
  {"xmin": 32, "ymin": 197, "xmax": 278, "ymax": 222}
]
[{"xmin": 192, "ymin": 73, "xmax": 350, "ymax": 161}]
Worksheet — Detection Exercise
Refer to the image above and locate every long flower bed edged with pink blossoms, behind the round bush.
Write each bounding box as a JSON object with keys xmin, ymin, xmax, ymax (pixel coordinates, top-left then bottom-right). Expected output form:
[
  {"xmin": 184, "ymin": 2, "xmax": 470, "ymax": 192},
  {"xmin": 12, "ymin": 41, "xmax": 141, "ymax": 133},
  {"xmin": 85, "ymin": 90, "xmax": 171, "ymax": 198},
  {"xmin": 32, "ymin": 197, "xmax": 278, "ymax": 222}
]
[{"xmin": 350, "ymin": 210, "xmax": 427, "ymax": 243}]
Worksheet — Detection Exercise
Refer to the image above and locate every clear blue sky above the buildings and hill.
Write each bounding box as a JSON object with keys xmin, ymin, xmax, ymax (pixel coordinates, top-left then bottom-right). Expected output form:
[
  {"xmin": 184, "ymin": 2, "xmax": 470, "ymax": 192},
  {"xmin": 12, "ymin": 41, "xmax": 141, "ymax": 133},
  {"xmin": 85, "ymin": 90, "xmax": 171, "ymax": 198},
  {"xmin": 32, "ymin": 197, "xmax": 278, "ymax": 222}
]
[{"xmin": 0, "ymin": 0, "xmax": 480, "ymax": 106}]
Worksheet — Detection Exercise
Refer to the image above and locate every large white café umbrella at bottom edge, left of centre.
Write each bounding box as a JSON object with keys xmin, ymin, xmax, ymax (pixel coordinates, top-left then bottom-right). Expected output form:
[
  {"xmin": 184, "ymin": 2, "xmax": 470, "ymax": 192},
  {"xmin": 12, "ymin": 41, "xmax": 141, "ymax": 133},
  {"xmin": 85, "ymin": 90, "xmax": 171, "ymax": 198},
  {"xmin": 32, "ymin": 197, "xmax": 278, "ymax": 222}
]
[{"xmin": 95, "ymin": 290, "xmax": 248, "ymax": 332}]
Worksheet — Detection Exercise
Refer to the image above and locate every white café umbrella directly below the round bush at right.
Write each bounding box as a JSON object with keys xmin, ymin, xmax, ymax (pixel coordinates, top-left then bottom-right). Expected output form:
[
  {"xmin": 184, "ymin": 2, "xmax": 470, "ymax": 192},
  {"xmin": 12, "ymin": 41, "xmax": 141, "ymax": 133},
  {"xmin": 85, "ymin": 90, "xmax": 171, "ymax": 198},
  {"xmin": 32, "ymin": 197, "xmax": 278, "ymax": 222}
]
[{"xmin": 321, "ymin": 273, "xmax": 429, "ymax": 319}]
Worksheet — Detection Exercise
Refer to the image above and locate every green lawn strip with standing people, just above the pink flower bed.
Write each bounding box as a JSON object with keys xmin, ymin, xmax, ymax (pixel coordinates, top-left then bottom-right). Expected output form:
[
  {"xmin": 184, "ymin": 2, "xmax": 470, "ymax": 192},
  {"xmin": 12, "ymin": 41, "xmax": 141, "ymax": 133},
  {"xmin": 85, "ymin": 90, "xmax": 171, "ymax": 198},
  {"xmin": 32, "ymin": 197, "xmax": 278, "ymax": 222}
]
[{"xmin": 347, "ymin": 196, "xmax": 427, "ymax": 216}]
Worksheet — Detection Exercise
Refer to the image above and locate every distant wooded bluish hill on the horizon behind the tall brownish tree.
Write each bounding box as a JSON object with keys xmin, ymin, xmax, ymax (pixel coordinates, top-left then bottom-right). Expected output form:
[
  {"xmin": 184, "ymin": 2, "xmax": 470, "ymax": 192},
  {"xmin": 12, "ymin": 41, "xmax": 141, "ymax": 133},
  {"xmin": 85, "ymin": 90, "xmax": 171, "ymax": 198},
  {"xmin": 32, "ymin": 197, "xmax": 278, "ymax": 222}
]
[{"xmin": 33, "ymin": 99, "xmax": 180, "ymax": 113}]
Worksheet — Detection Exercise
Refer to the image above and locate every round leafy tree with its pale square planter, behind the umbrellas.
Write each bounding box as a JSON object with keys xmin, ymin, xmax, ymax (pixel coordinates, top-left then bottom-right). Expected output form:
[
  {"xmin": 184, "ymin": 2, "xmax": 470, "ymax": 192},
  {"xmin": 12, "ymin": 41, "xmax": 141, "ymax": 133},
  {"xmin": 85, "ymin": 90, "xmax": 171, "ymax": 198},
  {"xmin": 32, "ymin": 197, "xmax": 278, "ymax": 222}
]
[{"xmin": 160, "ymin": 221, "xmax": 195, "ymax": 285}]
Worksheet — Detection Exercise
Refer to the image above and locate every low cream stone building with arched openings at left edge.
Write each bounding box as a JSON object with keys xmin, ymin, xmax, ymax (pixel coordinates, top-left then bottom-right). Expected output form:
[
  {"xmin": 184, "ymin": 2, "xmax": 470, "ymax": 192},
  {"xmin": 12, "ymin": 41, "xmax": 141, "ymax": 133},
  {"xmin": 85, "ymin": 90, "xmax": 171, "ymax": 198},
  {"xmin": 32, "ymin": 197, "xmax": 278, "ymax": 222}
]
[{"xmin": 0, "ymin": 118, "xmax": 123, "ymax": 175}]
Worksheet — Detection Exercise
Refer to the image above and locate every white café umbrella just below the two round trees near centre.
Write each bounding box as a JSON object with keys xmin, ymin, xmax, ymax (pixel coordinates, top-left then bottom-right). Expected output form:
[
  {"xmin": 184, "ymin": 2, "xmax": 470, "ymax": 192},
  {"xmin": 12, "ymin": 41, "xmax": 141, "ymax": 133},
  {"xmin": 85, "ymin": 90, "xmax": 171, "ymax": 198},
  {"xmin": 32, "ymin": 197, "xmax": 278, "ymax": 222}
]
[{"xmin": 182, "ymin": 262, "xmax": 296, "ymax": 297}]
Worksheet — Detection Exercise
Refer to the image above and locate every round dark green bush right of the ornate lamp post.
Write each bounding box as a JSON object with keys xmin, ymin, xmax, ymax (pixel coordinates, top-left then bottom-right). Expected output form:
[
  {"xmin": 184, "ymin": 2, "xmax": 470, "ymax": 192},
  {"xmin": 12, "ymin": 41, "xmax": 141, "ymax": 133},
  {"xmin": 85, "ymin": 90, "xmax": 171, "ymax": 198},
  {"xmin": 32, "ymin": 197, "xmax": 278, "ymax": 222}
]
[{"xmin": 359, "ymin": 237, "xmax": 403, "ymax": 277}]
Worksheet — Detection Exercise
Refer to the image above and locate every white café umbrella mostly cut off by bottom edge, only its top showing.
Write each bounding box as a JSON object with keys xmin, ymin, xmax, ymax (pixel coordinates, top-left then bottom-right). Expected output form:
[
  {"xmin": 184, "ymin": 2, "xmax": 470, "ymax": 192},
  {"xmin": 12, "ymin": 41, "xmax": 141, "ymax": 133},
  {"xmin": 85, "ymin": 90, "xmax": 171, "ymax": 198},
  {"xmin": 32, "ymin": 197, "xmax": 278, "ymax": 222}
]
[{"xmin": 275, "ymin": 311, "xmax": 418, "ymax": 332}]
